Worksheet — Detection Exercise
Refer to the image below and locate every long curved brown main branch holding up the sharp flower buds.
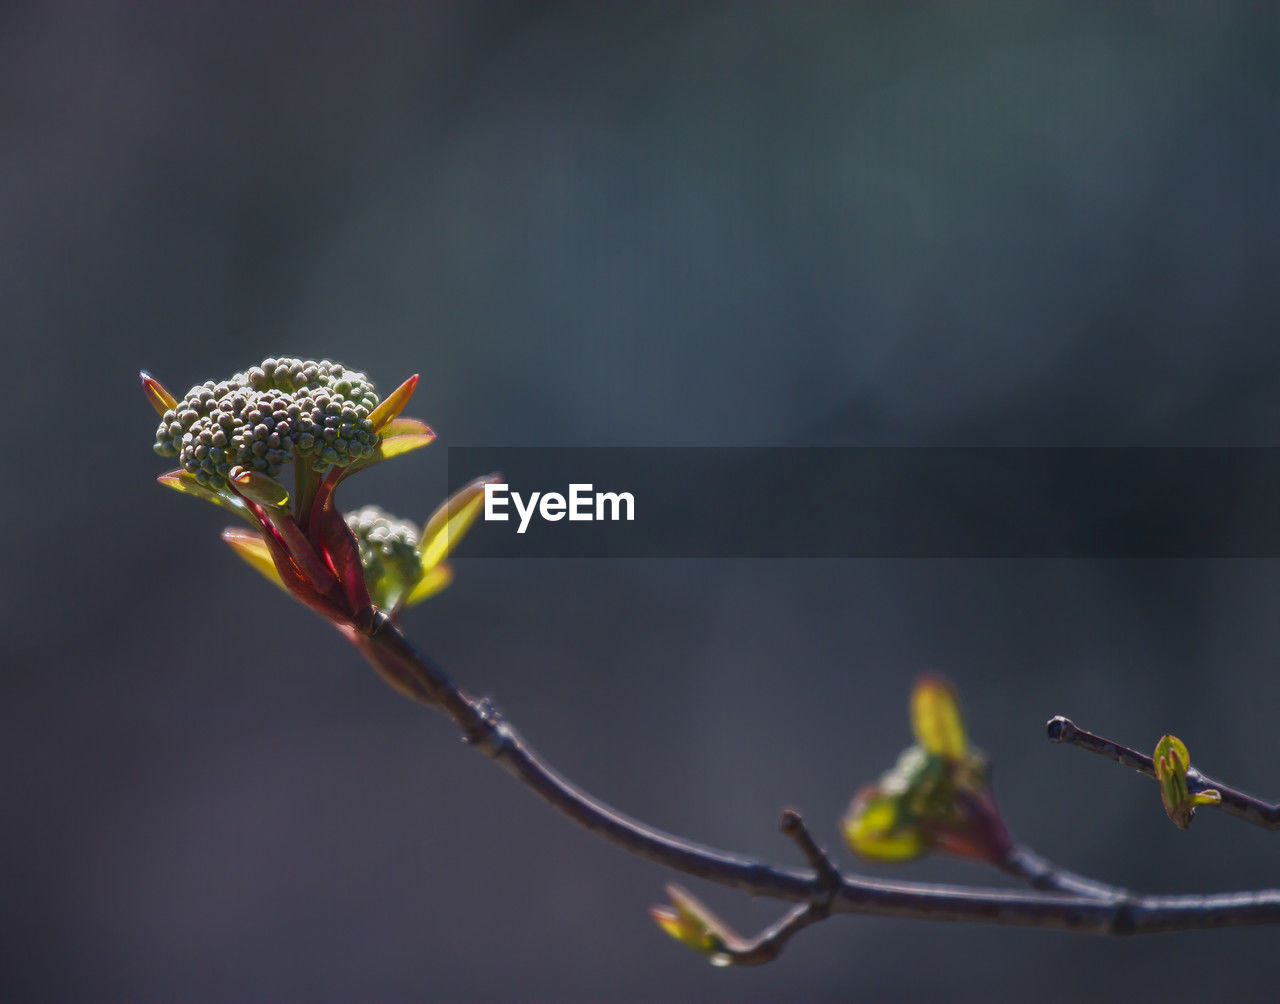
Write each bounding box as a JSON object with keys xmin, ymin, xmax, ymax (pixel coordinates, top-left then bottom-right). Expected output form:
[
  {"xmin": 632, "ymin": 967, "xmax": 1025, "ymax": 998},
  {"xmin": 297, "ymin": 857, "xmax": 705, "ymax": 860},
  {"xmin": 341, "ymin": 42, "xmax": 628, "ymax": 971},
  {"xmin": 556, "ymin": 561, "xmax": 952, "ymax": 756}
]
[{"xmin": 348, "ymin": 613, "xmax": 1280, "ymax": 960}]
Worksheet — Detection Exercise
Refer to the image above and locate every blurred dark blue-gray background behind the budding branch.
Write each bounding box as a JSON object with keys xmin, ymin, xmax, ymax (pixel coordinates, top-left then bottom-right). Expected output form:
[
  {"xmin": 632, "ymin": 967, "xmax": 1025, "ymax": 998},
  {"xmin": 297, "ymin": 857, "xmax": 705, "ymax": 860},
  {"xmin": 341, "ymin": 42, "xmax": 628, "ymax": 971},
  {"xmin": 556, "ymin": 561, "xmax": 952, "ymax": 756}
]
[{"xmin": 0, "ymin": 3, "xmax": 1280, "ymax": 1000}]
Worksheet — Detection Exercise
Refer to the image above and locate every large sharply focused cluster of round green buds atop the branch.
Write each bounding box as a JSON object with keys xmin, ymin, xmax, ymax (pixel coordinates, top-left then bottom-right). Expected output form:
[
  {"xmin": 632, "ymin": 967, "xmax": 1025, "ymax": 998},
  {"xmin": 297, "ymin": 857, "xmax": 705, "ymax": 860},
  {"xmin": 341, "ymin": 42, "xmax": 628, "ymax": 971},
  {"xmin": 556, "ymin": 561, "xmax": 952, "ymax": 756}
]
[{"xmin": 155, "ymin": 359, "xmax": 378, "ymax": 489}]
